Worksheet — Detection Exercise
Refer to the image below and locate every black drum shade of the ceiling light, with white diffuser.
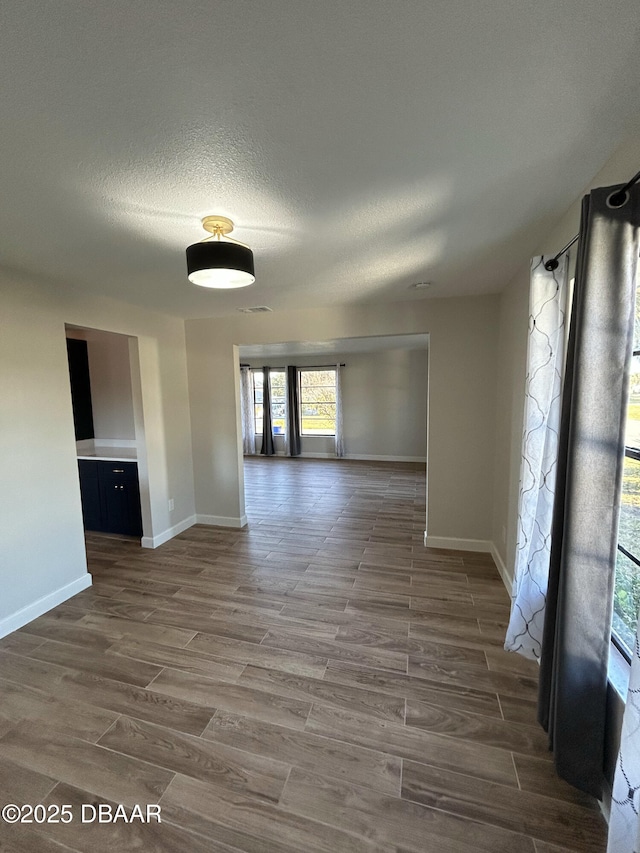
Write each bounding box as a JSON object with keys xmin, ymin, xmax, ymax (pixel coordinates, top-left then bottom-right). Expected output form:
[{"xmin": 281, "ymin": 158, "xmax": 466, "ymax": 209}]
[{"xmin": 187, "ymin": 240, "xmax": 256, "ymax": 289}]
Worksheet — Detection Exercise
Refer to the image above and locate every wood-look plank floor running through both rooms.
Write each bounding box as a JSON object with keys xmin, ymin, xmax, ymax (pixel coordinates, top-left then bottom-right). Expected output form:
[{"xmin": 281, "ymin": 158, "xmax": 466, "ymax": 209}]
[{"xmin": 0, "ymin": 458, "xmax": 606, "ymax": 853}]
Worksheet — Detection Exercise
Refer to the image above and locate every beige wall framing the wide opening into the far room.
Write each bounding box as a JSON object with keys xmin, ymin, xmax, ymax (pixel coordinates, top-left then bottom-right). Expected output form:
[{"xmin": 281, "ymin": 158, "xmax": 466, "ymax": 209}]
[{"xmin": 186, "ymin": 296, "xmax": 499, "ymax": 541}]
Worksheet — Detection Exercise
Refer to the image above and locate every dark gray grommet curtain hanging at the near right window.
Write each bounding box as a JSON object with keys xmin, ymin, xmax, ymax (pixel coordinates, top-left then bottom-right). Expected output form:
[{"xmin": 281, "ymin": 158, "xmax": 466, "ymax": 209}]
[{"xmin": 538, "ymin": 181, "xmax": 640, "ymax": 798}]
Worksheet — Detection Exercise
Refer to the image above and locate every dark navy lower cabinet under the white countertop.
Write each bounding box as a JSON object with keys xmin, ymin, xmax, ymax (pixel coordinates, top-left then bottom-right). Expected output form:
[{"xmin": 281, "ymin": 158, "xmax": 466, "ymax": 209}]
[{"xmin": 78, "ymin": 459, "xmax": 142, "ymax": 536}]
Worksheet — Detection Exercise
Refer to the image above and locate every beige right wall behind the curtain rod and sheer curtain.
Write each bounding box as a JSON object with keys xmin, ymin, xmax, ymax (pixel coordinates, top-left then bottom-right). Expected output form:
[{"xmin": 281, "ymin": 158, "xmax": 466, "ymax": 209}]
[{"xmin": 492, "ymin": 138, "xmax": 640, "ymax": 579}]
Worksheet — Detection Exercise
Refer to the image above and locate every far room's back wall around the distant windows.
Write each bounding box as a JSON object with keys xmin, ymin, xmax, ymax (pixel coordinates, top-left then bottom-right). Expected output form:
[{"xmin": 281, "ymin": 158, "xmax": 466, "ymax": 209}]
[{"xmin": 242, "ymin": 349, "xmax": 428, "ymax": 461}]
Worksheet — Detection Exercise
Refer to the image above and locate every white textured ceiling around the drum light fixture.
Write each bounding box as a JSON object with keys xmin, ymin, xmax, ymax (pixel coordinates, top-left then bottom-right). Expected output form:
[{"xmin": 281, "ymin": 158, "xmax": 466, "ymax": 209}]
[{"xmin": 0, "ymin": 0, "xmax": 640, "ymax": 317}]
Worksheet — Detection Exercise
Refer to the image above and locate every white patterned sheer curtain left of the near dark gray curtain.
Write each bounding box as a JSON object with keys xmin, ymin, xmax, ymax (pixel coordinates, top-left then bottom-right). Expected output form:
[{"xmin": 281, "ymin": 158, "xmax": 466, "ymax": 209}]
[{"xmin": 504, "ymin": 255, "xmax": 568, "ymax": 660}]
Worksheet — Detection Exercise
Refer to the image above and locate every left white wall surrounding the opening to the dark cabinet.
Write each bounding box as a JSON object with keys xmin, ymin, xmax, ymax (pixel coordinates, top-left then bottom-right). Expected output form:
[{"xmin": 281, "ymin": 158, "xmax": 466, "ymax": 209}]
[{"xmin": 0, "ymin": 273, "xmax": 194, "ymax": 635}]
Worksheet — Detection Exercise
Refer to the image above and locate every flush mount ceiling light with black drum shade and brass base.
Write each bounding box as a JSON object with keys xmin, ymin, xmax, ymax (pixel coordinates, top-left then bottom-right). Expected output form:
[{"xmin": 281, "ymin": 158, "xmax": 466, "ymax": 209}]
[{"xmin": 187, "ymin": 216, "xmax": 256, "ymax": 289}]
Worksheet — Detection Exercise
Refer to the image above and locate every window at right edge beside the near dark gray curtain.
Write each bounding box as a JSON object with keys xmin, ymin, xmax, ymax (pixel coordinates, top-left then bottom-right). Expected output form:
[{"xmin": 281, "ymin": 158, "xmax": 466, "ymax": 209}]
[{"xmin": 612, "ymin": 291, "xmax": 640, "ymax": 660}]
